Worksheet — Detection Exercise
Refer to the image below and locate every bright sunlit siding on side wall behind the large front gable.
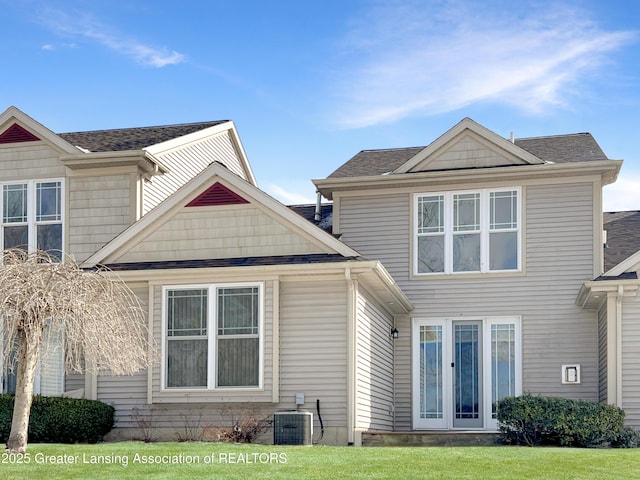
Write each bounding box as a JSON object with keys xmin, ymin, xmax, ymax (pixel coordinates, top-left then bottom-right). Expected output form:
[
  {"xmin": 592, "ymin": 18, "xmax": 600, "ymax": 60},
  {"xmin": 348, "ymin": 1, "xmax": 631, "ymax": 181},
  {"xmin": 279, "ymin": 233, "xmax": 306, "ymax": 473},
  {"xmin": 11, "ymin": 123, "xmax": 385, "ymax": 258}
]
[{"xmin": 143, "ymin": 132, "xmax": 247, "ymax": 214}]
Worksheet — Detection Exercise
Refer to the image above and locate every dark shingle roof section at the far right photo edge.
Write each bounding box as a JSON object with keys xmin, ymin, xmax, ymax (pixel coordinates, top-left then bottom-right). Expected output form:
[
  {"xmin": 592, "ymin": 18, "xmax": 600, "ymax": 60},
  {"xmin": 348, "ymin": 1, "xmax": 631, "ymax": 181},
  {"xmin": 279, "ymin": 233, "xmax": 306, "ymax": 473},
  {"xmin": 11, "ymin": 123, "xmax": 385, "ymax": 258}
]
[{"xmin": 603, "ymin": 210, "xmax": 640, "ymax": 272}]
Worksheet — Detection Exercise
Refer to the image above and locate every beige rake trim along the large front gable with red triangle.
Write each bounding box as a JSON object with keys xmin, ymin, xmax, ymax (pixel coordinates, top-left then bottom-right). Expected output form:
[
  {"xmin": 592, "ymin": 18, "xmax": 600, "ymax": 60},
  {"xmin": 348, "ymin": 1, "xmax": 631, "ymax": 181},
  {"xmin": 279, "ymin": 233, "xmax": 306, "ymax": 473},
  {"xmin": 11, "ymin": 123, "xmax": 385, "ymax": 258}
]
[{"xmin": 83, "ymin": 162, "xmax": 360, "ymax": 268}]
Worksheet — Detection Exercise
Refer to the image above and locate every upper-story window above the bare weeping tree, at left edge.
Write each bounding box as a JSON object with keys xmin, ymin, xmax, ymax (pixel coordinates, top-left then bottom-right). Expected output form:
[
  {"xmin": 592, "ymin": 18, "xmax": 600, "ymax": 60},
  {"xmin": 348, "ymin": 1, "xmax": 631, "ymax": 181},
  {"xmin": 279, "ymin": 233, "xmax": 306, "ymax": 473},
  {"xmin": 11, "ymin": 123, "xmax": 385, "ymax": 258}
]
[{"xmin": 0, "ymin": 180, "xmax": 64, "ymax": 259}]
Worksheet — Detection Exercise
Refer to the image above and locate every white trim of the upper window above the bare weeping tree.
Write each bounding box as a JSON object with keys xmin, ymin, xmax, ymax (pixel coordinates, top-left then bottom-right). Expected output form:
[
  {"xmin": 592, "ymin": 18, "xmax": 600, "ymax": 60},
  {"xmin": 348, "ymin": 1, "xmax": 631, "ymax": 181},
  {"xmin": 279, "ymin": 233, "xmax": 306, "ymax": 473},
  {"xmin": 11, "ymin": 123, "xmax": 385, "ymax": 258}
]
[{"xmin": 0, "ymin": 178, "xmax": 66, "ymax": 258}]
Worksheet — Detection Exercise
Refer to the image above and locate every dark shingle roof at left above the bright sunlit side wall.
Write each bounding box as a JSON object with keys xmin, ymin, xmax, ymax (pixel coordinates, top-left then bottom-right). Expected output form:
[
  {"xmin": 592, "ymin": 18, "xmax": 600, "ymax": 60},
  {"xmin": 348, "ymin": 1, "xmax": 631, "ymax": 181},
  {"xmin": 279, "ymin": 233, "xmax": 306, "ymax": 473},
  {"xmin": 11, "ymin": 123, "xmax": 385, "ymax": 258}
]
[{"xmin": 58, "ymin": 120, "xmax": 228, "ymax": 152}]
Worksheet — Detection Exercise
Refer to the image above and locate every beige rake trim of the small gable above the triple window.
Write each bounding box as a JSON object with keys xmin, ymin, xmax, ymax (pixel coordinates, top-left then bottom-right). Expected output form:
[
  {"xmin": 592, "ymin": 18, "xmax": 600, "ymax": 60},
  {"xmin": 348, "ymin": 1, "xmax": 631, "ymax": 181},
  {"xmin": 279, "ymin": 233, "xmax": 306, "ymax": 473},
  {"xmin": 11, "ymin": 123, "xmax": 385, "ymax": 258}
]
[{"xmin": 393, "ymin": 118, "xmax": 545, "ymax": 173}]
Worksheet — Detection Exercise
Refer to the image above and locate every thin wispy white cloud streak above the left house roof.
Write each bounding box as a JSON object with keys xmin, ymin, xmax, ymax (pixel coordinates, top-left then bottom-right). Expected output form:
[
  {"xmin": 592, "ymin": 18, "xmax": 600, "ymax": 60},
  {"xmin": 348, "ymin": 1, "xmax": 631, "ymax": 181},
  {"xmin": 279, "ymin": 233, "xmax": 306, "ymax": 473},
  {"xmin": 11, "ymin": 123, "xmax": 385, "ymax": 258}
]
[{"xmin": 40, "ymin": 9, "xmax": 186, "ymax": 68}]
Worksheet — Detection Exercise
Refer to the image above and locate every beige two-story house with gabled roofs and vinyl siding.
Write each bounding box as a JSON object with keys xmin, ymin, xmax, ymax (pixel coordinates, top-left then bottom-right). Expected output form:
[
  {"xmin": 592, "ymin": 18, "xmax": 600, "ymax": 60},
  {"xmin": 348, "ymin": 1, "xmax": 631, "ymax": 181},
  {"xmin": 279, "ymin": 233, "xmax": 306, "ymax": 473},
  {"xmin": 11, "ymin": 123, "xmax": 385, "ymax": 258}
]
[{"xmin": 0, "ymin": 107, "xmax": 640, "ymax": 444}]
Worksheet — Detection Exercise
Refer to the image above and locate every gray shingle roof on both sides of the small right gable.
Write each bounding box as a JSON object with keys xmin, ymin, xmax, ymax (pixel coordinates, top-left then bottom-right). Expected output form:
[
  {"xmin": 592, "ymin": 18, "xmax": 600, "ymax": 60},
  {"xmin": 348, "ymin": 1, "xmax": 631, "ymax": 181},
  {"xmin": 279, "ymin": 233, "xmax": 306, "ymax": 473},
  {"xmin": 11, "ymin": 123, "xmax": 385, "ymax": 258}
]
[{"xmin": 329, "ymin": 133, "xmax": 607, "ymax": 178}]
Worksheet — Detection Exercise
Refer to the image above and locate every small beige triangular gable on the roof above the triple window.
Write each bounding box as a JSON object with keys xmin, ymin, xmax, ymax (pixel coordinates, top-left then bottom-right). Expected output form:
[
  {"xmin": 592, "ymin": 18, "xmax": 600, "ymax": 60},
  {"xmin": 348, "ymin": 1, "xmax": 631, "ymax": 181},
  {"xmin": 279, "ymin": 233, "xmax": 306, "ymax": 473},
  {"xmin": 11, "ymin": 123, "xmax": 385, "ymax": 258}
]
[{"xmin": 393, "ymin": 118, "xmax": 545, "ymax": 173}]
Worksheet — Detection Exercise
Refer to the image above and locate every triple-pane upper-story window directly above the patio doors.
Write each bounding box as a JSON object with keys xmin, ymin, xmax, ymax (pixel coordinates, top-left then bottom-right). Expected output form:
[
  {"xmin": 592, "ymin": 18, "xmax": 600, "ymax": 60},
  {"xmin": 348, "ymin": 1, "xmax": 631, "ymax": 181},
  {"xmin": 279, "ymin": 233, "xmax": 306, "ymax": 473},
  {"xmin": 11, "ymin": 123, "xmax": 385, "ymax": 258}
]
[{"xmin": 414, "ymin": 188, "xmax": 521, "ymax": 274}]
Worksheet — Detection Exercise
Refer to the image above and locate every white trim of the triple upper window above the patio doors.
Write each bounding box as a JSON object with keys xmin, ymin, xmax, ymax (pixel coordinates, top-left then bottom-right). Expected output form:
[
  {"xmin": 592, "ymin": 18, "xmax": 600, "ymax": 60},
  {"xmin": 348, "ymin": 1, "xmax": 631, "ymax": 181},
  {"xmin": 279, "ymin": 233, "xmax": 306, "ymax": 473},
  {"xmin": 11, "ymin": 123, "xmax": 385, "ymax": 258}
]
[{"xmin": 412, "ymin": 187, "xmax": 523, "ymax": 277}]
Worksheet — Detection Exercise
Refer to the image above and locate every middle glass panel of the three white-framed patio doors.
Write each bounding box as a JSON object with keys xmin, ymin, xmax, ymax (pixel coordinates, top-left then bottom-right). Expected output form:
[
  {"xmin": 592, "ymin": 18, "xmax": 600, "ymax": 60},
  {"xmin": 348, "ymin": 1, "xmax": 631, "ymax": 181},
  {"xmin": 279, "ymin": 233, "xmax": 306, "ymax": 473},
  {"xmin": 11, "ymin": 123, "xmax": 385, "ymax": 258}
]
[{"xmin": 451, "ymin": 320, "xmax": 484, "ymax": 428}]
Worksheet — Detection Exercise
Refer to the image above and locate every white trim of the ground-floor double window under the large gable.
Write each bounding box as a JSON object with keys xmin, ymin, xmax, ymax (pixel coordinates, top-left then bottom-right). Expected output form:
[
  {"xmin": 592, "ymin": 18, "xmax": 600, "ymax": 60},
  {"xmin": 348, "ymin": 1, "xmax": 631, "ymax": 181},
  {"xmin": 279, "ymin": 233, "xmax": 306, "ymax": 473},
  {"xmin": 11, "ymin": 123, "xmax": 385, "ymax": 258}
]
[{"xmin": 160, "ymin": 282, "xmax": 265, "ymax": 393}]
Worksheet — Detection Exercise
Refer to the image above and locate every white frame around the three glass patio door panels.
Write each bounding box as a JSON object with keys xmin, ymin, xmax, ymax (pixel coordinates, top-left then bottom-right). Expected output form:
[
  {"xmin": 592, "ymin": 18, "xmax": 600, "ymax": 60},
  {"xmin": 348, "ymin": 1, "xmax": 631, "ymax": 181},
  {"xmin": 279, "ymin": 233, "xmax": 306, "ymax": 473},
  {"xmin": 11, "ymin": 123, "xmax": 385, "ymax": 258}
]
[{"xmin": 411, "ymin": 316, "xmax": 522, "ymax": 431}]
